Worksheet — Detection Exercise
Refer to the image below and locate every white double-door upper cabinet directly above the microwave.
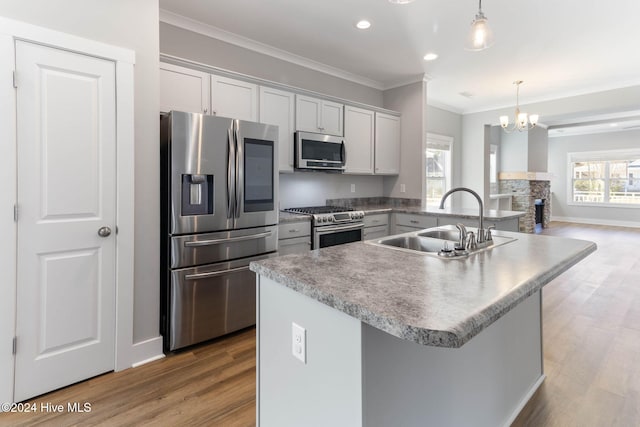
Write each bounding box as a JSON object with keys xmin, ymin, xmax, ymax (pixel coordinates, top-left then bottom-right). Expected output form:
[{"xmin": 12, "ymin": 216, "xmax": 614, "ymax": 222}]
[{"xmin": 296, "ymin": 95, "xmax": 344, "ymax": 136}]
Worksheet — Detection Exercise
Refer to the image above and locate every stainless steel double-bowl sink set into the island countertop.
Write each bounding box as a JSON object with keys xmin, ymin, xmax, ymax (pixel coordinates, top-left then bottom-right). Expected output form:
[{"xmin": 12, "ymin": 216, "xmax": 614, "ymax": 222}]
[{"xmin": 366, "ymin": 226, "xmax": 516, "ymax": 259}]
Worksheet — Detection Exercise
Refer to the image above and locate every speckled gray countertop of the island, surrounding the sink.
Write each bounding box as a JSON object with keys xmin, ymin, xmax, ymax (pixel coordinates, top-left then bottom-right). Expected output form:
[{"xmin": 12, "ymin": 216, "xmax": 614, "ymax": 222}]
[{"xmin": 250, "ymin": 231, "xmax": 596, "ymax": 347}]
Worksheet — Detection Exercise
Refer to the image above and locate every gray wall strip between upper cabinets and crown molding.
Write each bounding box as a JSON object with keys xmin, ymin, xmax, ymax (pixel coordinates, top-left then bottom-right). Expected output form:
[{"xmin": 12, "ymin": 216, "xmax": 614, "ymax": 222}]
[{"xmin": 160, "ymin": 23, "xmax": 382, "ymax": 107}]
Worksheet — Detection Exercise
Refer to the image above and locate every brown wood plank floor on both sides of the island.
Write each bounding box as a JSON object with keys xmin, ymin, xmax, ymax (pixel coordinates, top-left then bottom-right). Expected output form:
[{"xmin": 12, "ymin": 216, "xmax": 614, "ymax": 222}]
[{"xmin": 0, "ymin": 223, "xmax": 640, "ymax": 427}]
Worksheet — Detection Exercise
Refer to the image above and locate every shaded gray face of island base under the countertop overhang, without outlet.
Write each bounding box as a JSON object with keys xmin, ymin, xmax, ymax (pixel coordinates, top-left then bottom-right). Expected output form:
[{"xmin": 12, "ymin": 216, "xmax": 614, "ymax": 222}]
[{"xmin": 362, "ymin": 292, "xmax": 544, "ymax": 427}]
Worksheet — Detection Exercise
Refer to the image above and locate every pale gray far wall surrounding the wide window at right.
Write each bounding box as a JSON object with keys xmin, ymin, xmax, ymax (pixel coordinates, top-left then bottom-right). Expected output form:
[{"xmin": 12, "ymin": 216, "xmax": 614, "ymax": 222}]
[{"xmin": 549, "ymin": 130, "xmax": 640, "ymax": 226}]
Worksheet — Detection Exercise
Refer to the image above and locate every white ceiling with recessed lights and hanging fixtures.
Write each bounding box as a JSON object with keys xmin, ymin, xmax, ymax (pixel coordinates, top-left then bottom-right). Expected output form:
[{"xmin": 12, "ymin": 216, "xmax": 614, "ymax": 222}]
[{"xmin": 160, "ymin": 0, "xmax": 640, "ymax": 113}]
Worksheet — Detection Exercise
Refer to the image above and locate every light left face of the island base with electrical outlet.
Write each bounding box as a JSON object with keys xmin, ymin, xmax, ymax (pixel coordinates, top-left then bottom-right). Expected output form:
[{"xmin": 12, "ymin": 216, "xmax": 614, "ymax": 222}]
[{"xmin": 256, "ymin": 276, "xmax": 363, "ymax": 427}]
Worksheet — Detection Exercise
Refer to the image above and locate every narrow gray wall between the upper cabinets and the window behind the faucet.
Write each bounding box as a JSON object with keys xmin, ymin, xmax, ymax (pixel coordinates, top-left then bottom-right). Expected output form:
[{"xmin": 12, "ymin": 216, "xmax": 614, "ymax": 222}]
[{"xmin": 384, "ymin": 81, "xmax": 427, "ymax": 199}]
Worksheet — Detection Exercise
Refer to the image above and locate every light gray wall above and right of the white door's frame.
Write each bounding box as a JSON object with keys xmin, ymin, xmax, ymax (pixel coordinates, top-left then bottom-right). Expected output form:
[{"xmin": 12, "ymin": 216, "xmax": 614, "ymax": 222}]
[{"xmin": 0, "ymin": 0, "xmax": 160, "ymax": 342}]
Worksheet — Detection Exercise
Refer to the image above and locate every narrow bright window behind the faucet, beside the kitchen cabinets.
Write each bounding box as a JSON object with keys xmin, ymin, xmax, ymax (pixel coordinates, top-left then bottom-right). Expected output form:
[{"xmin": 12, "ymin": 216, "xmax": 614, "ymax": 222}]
[{"xmin": 425, "ymin": 133, "xmax": 453, "ymax": 206}]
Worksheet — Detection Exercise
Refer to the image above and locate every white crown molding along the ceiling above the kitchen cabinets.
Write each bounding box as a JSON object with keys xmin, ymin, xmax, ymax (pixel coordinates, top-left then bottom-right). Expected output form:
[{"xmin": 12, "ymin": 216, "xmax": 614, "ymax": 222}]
[{"xmin": 160, "ymin": 9, "xmax": 385, "ymax": 90}]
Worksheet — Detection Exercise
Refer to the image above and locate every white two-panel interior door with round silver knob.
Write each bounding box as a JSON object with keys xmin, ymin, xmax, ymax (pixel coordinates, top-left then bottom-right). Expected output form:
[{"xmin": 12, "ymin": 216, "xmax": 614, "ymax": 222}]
[{"xmin": 14, "ymin": 41, "xmax": 116, "ymax": 401}]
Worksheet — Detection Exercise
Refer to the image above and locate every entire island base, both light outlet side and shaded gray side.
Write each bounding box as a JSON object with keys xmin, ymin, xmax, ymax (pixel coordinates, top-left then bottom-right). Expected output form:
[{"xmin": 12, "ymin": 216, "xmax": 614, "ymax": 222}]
[{"xmin": 257, "ymin": 276, "xmax": 544, "ymax": 427}]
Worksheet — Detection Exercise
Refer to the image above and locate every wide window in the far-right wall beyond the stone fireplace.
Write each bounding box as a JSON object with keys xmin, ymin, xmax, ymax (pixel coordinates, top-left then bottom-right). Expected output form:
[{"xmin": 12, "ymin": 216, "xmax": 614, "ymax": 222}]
[{"xmin": 568, "ymin": 151, "xmax": 640, "ymax": 207}]
